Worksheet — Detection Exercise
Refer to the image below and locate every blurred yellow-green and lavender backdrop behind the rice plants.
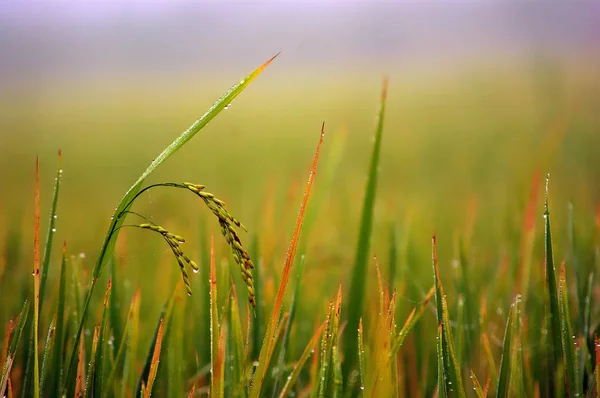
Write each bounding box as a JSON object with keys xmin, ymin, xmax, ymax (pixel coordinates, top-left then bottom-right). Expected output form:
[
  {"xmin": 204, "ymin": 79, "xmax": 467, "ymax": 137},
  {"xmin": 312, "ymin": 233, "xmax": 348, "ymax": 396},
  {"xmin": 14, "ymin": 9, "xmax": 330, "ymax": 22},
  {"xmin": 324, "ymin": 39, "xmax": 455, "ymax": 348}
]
[{"xmin": 0, "ymin": 0, "xmax": 600, "ymax": 298}]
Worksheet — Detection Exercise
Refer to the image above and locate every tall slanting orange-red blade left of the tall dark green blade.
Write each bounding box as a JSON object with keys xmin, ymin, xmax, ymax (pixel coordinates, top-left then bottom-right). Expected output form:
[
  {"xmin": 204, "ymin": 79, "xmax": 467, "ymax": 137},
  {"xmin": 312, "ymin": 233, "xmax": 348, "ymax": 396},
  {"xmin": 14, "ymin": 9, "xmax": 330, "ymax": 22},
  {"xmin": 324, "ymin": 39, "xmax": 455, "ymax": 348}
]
[{"xmin": 250, "ymin": 123, "xmax": 325, "ymax": 398}]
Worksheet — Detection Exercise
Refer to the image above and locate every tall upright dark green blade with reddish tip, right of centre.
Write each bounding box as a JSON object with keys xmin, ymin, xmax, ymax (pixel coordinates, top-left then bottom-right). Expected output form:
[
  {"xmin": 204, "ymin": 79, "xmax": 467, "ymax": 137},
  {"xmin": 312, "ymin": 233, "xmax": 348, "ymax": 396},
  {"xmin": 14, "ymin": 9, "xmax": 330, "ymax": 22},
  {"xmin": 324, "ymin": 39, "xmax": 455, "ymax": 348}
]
[{"xmin": 342, "ymin": 79, "xmax": 388, "ymax": 380}]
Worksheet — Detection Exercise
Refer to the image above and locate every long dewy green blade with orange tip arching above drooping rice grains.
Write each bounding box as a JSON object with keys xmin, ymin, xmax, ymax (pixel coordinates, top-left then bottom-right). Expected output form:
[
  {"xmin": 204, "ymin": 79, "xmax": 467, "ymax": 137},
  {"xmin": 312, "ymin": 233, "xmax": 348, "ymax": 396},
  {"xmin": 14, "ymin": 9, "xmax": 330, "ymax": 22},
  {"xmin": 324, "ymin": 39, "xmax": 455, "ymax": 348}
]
[{"xmin": 63, "ymin": 54, "xmax": 279, "ymax": 392}]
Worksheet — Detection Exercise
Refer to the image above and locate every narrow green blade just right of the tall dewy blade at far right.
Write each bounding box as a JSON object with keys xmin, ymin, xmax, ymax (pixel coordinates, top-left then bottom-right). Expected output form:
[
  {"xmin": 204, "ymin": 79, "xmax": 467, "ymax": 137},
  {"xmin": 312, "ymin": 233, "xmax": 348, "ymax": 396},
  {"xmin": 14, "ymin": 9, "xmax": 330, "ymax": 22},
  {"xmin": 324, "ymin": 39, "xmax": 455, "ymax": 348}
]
[{"xmin": 558, "ymin": 262, "xmax": 582, "ymax": 397}]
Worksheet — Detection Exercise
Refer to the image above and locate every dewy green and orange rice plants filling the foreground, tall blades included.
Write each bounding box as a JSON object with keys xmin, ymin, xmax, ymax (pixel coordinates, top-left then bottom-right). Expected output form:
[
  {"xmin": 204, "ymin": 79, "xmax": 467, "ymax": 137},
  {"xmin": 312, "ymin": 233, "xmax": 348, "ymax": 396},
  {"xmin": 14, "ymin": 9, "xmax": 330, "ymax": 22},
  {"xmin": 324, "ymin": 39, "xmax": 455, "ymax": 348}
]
[{"xmin": 0, "ymin": 57, "xmax": 600, "ymax": 398}]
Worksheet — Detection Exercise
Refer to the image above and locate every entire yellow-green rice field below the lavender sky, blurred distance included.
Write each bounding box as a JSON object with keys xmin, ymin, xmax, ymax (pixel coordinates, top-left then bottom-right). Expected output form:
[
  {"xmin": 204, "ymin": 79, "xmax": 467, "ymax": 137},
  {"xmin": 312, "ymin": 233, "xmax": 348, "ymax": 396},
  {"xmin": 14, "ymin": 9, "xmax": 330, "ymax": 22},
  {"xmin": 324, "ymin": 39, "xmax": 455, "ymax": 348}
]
[{"xmin": 0, "ymin": 54, "xmax": 600, "ymax": 397}]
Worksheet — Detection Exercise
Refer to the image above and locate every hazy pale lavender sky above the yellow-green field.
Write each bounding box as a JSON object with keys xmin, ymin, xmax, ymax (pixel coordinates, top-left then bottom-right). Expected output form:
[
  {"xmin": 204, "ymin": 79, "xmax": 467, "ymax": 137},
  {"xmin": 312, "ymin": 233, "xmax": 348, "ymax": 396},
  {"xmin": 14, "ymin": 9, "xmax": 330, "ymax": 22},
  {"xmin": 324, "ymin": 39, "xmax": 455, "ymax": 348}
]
[{"xmin": 0, "ymin": 0, "xmax": 600, "ymax": 85}]
